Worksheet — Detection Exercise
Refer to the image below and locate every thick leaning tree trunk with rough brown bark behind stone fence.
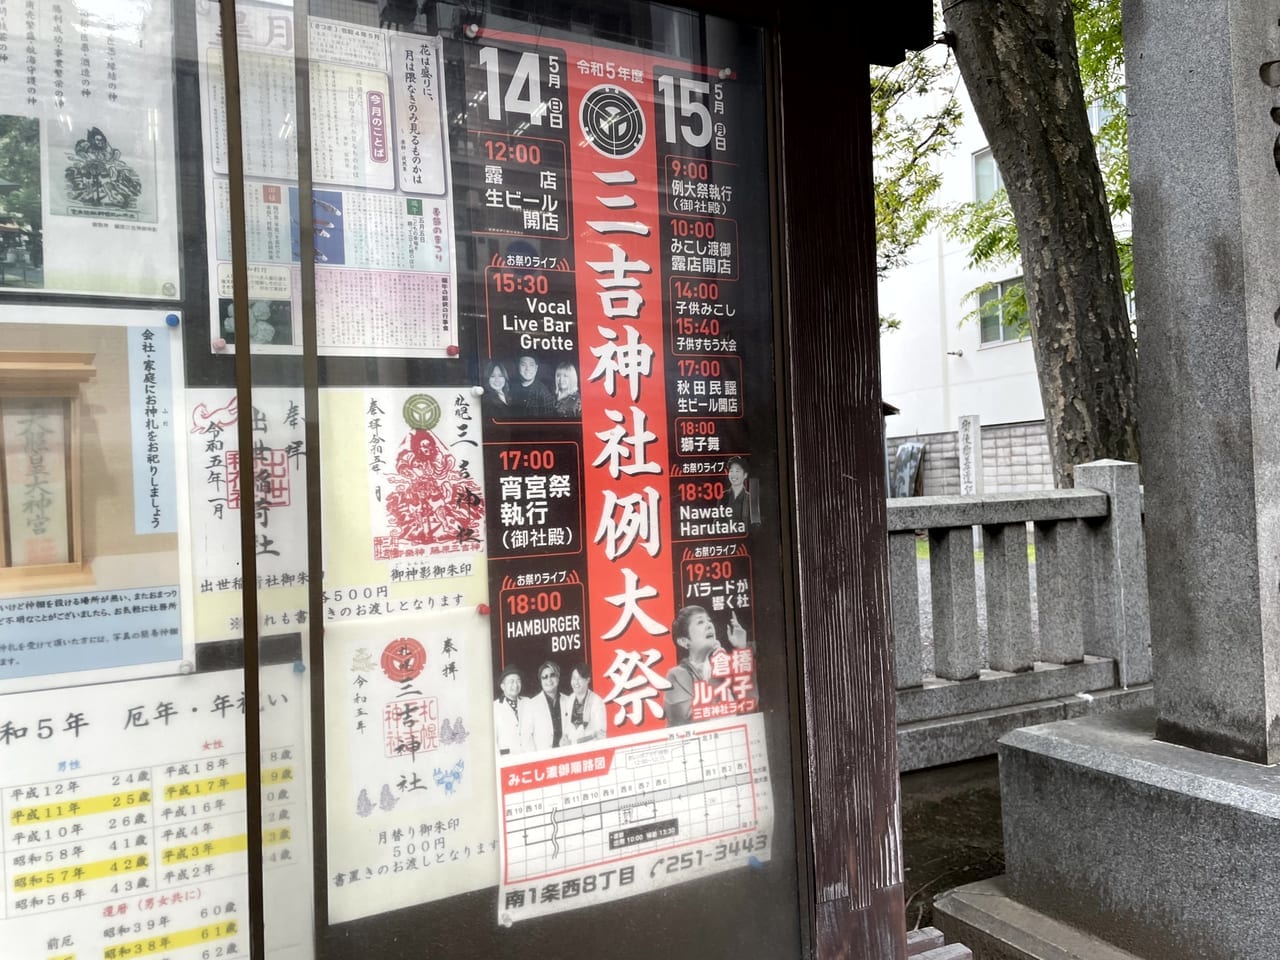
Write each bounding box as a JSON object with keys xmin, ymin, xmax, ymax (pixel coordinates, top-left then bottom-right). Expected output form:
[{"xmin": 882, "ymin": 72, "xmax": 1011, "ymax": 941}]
[{"xmin": 943, "ymin": 0, "xmax": 1138, "ymax": 486}]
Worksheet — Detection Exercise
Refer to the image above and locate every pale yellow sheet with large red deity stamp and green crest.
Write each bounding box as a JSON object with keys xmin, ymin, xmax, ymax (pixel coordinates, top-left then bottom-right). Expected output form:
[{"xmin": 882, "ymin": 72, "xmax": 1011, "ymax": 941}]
[{"xmin": 320, "ymin": 387, "xmax": 488, "ymax": 621}]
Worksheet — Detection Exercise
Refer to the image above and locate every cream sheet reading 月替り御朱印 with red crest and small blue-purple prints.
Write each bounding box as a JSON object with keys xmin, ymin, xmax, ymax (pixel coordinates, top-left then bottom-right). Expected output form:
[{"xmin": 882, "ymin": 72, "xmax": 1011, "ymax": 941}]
[{"xmin": 325, "ymin": 616, "xmax": 498, "ymax": 923}]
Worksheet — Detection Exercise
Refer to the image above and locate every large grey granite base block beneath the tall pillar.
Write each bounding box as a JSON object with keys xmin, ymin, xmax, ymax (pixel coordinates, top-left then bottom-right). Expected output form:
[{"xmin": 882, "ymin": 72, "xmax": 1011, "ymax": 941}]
[{"xmin": 965, "ymin": 710, "xmax": 1280, "ymax": 960}]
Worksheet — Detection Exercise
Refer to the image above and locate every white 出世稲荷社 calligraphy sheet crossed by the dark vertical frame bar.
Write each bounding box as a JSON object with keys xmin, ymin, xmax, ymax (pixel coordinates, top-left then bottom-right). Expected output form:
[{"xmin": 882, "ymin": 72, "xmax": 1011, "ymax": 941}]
[{"xmin": 182, "ymin": 387, "xmax": 310, "ymax": 643}]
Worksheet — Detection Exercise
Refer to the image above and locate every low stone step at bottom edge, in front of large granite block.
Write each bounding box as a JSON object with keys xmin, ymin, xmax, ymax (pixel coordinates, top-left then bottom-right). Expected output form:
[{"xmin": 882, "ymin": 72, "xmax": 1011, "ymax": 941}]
[{"xmin": 933, "ymin": 877, "xmax": 1139, "ymax": 960}]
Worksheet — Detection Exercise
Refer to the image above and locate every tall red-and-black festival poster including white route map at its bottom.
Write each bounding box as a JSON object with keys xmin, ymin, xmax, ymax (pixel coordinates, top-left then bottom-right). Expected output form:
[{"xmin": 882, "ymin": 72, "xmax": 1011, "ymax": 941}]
[{"xmin": 465, "ymin": 29, "xmax": 783, "ymax": 923}]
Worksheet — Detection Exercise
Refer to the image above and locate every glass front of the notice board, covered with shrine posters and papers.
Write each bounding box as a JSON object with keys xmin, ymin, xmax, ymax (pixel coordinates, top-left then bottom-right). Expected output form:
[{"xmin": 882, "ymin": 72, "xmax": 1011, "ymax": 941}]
[{"xmin": 0, "ymin": 0, "xmax": 803, "ymax": 960}]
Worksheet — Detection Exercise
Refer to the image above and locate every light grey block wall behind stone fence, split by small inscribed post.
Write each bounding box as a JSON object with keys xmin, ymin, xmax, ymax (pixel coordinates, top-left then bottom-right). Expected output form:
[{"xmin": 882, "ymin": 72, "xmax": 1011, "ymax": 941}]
[{"xmin": 886, "ymin": 420, "xmax": 1053, "ymax": 497}]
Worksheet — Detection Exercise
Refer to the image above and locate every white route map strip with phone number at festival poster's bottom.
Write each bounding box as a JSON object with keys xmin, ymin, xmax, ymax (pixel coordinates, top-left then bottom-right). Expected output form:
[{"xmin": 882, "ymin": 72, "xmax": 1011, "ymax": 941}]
[{"xmin": 498, "ymin": 713, "xmax": 773, "ymax": 924}]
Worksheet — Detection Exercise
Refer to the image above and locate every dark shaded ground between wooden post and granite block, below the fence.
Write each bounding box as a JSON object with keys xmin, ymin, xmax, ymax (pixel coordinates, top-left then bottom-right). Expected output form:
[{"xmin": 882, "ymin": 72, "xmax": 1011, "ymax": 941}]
[{"xmin": 902, "ymin": 756, "xmax": 1005, "ymax": 929}]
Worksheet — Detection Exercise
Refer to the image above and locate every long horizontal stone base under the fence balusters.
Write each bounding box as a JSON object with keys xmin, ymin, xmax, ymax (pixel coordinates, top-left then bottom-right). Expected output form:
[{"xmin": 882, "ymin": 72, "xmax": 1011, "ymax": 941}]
[{"xmin": 897, "ymin": 686, "xmax": 1153, "ymax": 773}]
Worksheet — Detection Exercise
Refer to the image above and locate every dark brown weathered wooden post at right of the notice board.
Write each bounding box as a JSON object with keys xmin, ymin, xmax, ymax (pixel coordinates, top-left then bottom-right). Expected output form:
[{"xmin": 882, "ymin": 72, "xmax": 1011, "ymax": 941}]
[{"xmin": 780, "ymin": 8, "xmax": 906, "ymax": 960}]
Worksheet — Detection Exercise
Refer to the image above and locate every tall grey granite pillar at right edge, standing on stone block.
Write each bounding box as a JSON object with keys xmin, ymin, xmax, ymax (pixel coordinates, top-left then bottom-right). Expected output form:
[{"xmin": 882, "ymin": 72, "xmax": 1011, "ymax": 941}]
[{"xmin": 1124, "ymin": 0, "xmax": 1280, "ymax": 763}]
